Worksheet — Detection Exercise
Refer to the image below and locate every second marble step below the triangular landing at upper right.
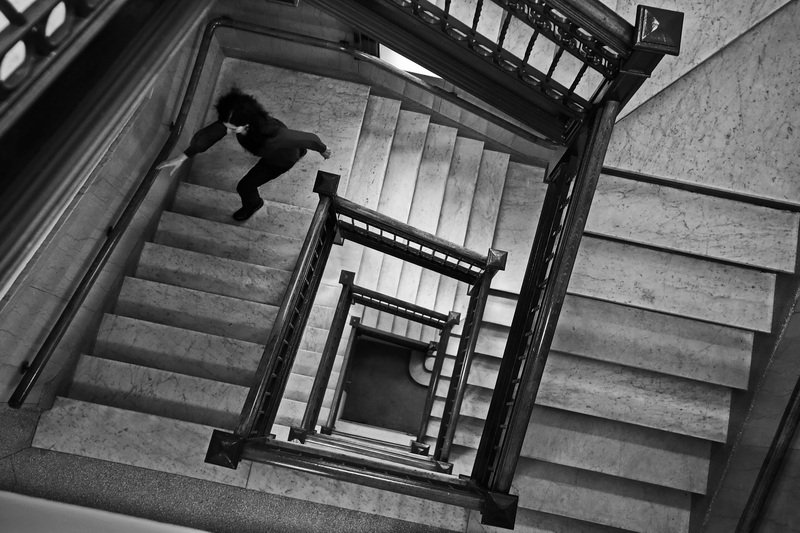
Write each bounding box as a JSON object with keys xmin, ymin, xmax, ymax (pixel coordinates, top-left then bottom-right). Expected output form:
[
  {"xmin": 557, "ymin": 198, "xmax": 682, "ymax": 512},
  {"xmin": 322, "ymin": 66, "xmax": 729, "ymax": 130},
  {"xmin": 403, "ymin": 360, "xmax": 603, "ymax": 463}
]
[{"xmin": 568, "ymin": 237, "xmax": 775, "ymax": 331}]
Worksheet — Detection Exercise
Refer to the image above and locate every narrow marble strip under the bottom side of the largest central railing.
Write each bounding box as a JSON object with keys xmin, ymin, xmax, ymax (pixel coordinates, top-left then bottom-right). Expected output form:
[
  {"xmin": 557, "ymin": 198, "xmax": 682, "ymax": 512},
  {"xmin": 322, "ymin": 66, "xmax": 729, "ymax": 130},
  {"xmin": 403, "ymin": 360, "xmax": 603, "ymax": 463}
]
[{"xmin": 247, "ymin": 463, "xmax": 467, "ymax": 531}]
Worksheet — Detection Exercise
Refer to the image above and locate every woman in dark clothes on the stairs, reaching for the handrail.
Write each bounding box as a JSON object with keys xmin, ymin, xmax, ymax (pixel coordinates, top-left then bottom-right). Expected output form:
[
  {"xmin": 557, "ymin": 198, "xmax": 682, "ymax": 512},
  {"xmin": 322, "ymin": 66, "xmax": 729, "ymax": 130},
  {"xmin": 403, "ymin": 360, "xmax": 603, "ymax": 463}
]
[{"xmin": 157, "ymin": 87, "xmax": 331, "ymax": 221}]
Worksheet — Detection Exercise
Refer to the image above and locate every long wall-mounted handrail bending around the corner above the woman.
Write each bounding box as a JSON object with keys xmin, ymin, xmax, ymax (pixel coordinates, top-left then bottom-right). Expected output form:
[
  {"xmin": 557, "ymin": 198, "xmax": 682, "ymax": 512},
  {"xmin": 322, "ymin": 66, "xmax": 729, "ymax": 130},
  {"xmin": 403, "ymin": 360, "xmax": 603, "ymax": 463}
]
[{"xmin": 8, "ymin": 13, "xmax": 553, "ymax": 409}]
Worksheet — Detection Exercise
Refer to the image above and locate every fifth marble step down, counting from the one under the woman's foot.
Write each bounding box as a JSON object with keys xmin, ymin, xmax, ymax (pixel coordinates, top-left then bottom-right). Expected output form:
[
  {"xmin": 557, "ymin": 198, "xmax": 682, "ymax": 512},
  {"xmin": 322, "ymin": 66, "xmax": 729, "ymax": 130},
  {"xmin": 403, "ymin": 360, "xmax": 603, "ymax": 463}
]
[{"xmin": 93, "ymin": 314, "xmax": 264, "ymax": 387}]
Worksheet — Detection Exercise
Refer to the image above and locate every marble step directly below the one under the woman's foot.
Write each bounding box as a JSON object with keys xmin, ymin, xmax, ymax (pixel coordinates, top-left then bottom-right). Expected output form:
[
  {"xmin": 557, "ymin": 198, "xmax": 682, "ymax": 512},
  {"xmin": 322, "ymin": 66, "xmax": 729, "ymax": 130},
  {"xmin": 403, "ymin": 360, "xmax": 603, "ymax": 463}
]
[{"xmin": 153, "ymin": 211, "xmax": 303, "ymax": 270}]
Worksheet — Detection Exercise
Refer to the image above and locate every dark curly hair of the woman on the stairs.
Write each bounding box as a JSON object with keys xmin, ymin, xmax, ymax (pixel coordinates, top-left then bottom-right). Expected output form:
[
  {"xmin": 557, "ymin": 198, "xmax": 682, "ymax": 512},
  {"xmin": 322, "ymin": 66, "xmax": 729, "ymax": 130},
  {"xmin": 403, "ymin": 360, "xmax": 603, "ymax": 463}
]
[{"xmin": 215, "ymin": 87, "xmax": 283, "ymax": 155}]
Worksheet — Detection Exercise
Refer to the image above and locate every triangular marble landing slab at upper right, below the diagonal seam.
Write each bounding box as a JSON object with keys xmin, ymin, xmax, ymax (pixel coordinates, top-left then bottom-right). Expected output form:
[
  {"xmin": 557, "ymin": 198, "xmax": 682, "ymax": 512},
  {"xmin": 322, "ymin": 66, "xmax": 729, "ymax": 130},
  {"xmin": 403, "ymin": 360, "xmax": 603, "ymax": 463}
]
[{"xmin": 606, "ymin": 2, "xmax": 800, "ymax": 204}]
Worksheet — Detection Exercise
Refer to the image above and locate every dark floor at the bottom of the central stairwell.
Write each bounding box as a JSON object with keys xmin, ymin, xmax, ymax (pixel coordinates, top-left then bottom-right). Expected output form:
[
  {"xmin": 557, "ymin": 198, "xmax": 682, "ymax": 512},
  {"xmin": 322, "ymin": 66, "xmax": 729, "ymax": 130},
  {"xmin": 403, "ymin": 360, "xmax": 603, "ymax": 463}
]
[{"xmin": 341, "ymin": 328, "xmax": 427, "ymax": 435}]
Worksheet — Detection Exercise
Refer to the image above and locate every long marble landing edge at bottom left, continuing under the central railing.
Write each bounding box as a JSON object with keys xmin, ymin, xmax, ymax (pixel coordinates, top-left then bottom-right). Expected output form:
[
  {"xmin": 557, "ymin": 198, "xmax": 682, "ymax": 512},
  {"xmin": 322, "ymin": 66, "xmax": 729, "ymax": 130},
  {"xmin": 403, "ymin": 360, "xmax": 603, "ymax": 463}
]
[{"xmin": 32, "ymin": 397, "xmax": 466, "ymax": 530}]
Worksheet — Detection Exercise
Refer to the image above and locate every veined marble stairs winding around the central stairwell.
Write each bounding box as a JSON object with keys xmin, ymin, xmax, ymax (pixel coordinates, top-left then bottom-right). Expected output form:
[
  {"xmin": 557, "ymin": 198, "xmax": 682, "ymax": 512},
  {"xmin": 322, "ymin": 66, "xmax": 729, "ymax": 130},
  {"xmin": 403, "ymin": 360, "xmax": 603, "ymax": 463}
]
[{"xmin": 26, "ymin": 14, "xmax": 800, "ymax": 532}]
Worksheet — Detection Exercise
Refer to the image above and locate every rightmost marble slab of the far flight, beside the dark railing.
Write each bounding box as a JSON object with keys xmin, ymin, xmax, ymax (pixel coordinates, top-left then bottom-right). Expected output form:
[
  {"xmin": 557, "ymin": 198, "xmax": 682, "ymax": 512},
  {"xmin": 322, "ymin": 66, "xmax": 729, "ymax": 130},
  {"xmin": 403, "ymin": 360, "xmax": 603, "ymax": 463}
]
[{"xmin": 492, "ymin": 162, "xmax": 547, "ymax": 293}]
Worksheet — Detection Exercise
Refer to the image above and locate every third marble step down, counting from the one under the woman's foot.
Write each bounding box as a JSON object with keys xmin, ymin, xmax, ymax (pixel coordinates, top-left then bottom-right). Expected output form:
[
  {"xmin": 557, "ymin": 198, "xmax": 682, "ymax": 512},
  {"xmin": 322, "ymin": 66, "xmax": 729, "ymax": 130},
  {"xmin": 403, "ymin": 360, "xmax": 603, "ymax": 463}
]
[{"xmin": 136, "ymin": 243, "xmax": 292, "ymax": 305}]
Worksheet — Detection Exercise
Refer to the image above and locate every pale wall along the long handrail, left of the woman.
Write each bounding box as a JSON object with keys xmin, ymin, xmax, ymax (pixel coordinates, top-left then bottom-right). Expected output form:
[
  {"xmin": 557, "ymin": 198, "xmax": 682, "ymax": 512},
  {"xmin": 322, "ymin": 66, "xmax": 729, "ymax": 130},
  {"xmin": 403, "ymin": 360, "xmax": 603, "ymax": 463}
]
[{"xmin": 0, "ymin": 3, "xmax": 220, "ymax": 406}]
